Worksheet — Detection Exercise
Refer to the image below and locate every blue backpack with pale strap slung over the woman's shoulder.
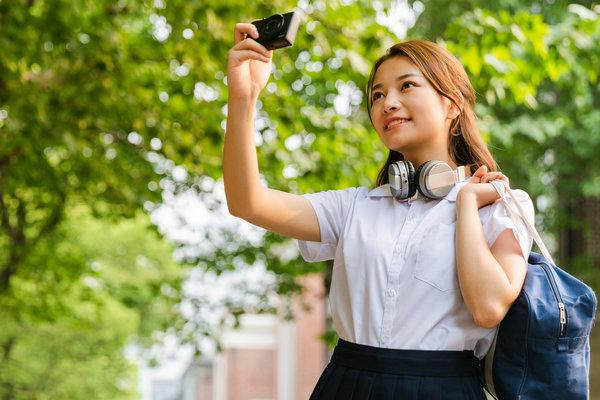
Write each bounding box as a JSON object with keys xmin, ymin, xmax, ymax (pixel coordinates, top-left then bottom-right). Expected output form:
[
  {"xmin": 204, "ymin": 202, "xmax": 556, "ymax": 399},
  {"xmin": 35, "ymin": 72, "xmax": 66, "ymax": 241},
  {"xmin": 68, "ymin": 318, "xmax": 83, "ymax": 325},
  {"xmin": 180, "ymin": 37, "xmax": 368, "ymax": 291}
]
[{"xmin": 482, "ymin": 181, "xmax": 596, "ymax": 400}]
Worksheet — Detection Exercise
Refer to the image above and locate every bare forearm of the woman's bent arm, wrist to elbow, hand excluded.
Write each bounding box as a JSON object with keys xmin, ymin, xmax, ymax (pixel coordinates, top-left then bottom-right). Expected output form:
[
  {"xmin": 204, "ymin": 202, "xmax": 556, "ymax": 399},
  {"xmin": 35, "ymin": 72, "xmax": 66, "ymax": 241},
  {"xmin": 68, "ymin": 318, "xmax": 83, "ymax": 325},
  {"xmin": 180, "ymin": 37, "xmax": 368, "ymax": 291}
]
[{"xmin": 456, "ymin": 193, "xmax": 515, "ymax": 327}]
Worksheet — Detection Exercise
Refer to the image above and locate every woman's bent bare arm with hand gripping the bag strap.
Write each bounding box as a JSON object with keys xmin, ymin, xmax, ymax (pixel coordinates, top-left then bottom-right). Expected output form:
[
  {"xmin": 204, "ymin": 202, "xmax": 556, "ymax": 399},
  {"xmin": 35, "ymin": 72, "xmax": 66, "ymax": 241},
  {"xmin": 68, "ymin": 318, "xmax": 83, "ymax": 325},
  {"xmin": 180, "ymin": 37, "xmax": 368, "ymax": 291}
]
[{"xmin": 456, "ymin": 167, "xmax": 527, "ymax": 328}]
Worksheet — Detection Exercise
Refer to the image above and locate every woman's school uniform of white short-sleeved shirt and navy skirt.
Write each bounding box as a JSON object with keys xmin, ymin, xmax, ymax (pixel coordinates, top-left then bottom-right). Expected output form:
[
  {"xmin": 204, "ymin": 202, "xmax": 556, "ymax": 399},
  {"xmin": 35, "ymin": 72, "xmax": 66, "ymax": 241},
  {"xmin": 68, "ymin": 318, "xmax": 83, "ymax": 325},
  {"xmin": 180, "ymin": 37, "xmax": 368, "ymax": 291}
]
[{"xmin": 299, "ymin": 182, "xmax": 533, "ymax": 400}]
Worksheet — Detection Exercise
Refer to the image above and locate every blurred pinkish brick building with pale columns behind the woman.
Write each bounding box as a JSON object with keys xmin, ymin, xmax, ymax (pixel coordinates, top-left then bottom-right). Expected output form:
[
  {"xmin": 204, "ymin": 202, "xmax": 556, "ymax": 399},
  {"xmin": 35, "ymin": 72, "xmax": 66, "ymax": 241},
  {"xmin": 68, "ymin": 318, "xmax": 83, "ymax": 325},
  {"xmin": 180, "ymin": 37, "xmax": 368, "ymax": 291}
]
[{"xmin": 151, "ymin": 275, "xmax": 330, "ymax": 400}]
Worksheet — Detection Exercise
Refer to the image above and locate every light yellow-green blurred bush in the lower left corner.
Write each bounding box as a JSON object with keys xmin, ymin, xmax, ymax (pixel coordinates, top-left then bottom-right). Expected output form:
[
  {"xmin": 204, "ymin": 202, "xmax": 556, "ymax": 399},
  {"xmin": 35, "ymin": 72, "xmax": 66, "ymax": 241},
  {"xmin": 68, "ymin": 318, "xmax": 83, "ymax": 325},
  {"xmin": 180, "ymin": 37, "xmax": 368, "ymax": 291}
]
[{"xmin": 0, "ymin": 206, "xmax": 182, "ymax": 400}]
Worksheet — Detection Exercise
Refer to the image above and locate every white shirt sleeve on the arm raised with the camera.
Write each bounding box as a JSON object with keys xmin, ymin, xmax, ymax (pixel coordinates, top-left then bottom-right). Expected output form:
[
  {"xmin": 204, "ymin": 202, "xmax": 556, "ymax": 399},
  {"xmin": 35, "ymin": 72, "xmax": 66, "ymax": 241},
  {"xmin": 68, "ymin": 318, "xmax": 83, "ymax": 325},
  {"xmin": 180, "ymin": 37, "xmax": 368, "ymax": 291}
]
[{"xmin": 298, "ymin": 188, "xmax": 358, "ymax": 262}]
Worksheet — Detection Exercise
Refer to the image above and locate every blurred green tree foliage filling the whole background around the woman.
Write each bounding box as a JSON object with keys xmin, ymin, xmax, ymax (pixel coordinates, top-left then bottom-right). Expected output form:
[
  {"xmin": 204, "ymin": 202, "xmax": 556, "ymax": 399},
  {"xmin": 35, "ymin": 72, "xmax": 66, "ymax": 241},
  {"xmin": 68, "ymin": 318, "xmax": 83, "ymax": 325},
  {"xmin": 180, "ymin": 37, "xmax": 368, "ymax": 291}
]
[{"xmin": 0, "ymin": 0, "xmax": 600, "ymax": 399}]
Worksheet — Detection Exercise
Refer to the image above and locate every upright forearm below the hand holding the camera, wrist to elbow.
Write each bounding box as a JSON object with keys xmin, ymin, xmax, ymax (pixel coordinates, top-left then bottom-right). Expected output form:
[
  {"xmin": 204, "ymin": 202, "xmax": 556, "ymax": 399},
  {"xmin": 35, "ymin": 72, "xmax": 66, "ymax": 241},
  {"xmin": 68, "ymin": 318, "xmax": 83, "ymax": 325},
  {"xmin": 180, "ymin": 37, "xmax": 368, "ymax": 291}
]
[{"xmin": 223, "ymin": 96, "xmax": 264, "ymax": 216}]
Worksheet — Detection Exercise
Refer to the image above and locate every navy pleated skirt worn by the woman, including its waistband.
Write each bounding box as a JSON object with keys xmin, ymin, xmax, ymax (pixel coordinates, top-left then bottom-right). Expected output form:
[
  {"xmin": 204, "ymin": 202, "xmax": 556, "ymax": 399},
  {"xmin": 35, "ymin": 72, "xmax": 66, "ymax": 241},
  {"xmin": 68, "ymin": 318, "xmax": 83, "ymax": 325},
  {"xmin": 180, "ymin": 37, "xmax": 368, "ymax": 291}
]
[{"xmin": 310, "ymin": 339, "xmax": 486, "ymax": 400}]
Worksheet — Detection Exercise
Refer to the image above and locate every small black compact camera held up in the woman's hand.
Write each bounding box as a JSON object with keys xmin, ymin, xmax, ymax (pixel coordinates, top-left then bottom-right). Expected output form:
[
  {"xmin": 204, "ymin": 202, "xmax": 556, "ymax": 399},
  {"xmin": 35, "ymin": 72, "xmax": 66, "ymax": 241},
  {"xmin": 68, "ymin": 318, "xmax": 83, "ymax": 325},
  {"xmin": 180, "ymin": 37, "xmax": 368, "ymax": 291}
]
[{"xmin": 253, "ymin": 12, "xmax": 300, "ymax": 50}]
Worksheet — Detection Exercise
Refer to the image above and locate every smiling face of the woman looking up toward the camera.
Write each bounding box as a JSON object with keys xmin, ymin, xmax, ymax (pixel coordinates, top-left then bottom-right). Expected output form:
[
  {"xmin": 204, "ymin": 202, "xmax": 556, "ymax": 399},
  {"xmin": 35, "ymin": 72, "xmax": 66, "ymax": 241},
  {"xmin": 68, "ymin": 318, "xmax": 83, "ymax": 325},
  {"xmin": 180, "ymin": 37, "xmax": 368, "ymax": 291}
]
[{"xmin": 371, "ymin": 56, "xmax": 457, "ymax": 165}]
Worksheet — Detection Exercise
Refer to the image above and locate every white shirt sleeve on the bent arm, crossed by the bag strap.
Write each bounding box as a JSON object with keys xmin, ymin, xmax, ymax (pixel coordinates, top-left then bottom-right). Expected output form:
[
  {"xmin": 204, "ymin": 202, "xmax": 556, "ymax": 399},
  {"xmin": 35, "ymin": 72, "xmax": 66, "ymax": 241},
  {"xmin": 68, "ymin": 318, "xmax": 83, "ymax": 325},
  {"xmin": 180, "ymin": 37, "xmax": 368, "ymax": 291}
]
[{"xmin": 480, "ymin": 190, "xmax": 535, "ymax": 260}]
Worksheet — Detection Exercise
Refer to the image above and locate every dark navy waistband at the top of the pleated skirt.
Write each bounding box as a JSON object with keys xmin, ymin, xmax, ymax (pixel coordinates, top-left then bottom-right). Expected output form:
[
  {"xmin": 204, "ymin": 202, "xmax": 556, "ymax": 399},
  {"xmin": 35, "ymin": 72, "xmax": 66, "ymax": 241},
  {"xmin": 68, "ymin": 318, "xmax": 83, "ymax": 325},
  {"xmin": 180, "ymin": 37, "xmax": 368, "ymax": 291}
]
[{"xmin": 331, "ymin": 339, "xmax": 479, "ymax": 377}]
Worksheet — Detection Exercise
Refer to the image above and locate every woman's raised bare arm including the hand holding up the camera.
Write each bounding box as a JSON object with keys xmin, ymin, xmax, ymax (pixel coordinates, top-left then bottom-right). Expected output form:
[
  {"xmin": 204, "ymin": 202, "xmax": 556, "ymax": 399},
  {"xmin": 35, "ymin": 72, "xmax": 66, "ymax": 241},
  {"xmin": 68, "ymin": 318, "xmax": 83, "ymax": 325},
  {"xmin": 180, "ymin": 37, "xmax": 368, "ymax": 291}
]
[{"xmin": 223, "ymin": 23, "xmax": 321, "ymax": 241}]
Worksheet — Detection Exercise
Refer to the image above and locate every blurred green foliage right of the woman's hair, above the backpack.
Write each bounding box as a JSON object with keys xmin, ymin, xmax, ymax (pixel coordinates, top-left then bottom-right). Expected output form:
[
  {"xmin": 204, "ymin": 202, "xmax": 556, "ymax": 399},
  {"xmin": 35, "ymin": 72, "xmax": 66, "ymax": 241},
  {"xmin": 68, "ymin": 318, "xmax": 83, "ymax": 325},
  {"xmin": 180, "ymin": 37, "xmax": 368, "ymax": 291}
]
[{"xmin": 436, "ymin": 4, "xmax": 600, "ymax": 288}]
